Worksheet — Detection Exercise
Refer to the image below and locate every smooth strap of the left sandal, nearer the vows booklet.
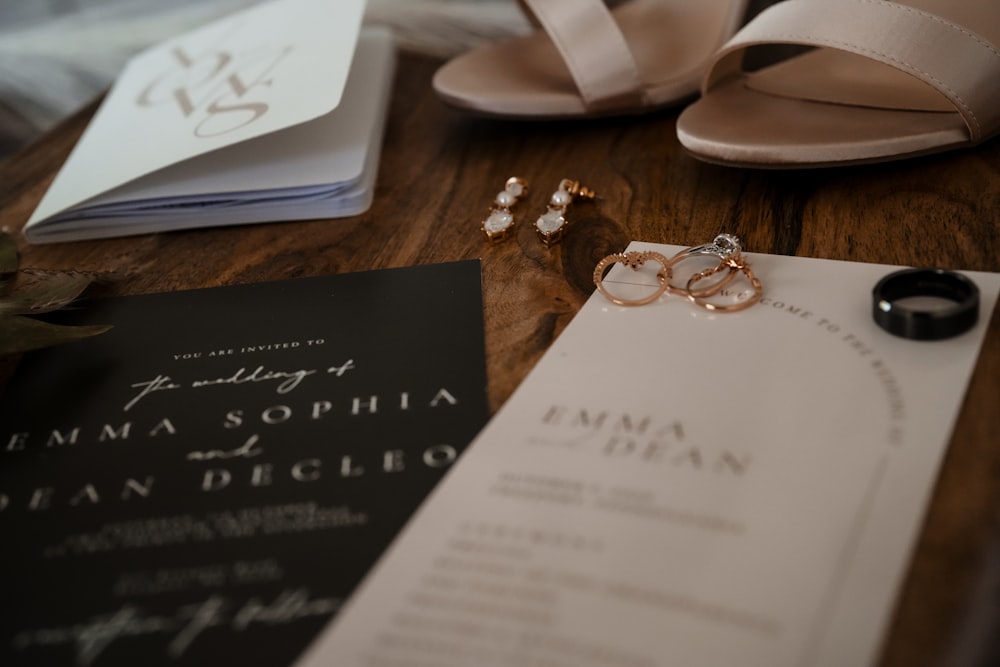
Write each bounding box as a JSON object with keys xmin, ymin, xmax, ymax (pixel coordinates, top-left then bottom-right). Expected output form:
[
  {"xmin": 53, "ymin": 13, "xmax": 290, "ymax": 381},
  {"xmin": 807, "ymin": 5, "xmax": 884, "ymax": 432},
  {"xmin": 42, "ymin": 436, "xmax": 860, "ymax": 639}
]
[{"xmin": 520, "ymin": 0, "xmax": 643, "ymax": 108}]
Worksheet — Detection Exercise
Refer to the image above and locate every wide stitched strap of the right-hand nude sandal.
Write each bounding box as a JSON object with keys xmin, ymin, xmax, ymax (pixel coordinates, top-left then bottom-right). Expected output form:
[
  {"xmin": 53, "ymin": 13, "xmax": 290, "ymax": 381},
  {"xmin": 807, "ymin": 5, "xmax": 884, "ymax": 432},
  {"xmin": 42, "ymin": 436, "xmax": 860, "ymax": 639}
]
[{"xmin": 703, "ymin": 0, "xmax": 1000, "ymax": 142}]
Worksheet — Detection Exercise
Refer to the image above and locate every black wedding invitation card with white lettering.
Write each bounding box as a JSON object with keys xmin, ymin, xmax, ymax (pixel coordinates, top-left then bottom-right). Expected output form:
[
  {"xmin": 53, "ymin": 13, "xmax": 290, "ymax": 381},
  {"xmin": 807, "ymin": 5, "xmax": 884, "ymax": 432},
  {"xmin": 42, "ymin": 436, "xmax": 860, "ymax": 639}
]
[{"xmin": 0, "ymin": 261, "xmax": 488, "ymax": 667}]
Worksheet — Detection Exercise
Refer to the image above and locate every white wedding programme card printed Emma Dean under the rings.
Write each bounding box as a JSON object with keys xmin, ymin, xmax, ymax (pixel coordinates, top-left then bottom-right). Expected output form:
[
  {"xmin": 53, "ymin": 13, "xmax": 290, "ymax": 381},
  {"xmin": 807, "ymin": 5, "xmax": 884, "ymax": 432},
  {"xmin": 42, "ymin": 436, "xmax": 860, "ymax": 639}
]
[{"xmin": 299, "ymin": 244, "xmax": 1000, "ymax": 667}]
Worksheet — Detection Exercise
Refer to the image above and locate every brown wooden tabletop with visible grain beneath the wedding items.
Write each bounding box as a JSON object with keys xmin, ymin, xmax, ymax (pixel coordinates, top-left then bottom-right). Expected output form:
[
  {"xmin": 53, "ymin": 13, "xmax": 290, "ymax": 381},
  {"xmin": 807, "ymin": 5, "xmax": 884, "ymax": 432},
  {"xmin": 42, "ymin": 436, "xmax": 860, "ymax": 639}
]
[{"xmin": 0, "ymin": 44, "xmax": 1000, "ymax": 667}]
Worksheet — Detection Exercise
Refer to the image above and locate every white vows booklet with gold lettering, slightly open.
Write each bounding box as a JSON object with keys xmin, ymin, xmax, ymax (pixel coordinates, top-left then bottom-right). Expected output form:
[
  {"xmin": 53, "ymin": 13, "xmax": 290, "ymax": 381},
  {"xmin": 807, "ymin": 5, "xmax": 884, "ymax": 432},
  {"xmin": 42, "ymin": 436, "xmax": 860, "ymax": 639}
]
[{"xmin": 25, "ymin": 0, "xmax": 395, "ymax": 243}]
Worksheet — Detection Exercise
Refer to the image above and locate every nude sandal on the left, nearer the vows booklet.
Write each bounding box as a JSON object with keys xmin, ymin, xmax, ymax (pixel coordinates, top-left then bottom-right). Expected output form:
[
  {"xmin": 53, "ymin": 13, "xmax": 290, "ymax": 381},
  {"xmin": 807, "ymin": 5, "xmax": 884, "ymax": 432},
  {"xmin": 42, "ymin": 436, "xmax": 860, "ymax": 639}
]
[{"xmin": 434, "ymin": 0, "xmax": 748, "ymax": 119}]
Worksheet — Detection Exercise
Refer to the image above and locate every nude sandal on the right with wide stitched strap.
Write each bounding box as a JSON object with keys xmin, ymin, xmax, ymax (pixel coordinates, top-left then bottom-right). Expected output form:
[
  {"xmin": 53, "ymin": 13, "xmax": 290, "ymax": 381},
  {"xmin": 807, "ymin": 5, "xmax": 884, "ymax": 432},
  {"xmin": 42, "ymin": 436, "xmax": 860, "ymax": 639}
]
[{"xmin": 677, "ymin": 0, "xmax": 1000, "ymax": 168}]
